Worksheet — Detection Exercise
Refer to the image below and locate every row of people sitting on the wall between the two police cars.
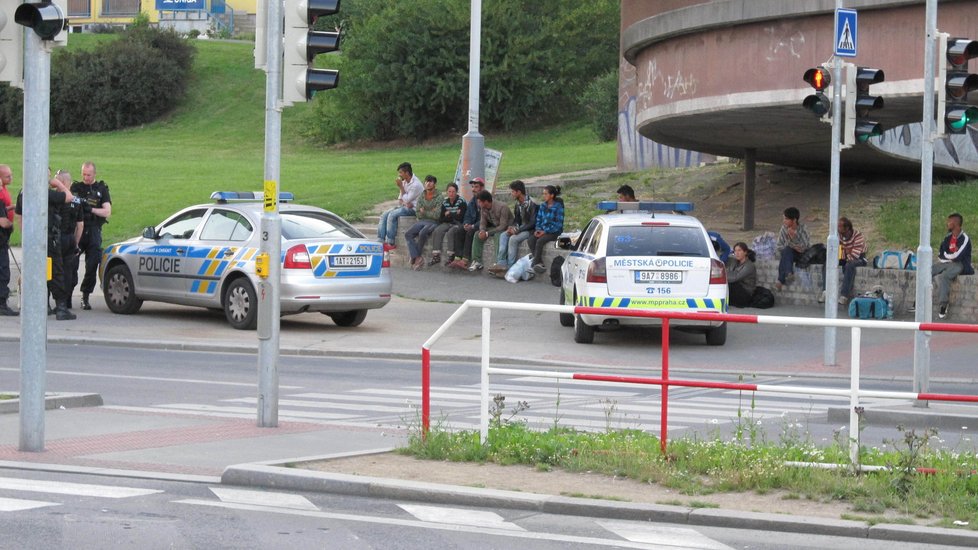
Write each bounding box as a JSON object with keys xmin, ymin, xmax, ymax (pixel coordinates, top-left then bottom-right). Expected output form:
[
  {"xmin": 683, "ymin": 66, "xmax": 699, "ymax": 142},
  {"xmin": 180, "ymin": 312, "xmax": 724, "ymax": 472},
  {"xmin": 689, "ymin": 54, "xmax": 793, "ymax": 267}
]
[{"xmin": 377, "ymin": 163, "xmax": 564, "ymax": 277}]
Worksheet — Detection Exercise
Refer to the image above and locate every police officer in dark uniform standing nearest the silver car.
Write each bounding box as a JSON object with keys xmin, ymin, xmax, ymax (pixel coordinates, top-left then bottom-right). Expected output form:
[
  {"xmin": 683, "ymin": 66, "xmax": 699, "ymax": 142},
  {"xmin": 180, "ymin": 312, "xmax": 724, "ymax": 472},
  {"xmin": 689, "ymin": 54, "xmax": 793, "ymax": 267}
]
[{"xmin": 67, "ymin": 161, "xmax": 112, "ymax": 310}]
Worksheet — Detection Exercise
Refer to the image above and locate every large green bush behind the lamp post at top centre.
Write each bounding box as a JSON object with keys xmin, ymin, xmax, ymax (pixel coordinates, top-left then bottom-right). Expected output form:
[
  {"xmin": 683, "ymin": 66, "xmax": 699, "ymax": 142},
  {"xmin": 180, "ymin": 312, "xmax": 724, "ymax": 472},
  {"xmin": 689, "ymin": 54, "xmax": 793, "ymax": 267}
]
[{"xmin": 311, "ymin": 0, "xmax": 619, "ymax": 143}]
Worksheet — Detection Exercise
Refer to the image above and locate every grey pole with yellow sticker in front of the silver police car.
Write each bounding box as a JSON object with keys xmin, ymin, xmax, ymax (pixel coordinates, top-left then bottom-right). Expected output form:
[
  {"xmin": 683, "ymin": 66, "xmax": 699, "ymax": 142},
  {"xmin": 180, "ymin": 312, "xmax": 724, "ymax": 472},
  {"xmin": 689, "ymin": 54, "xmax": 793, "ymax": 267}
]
[{"xmin": 257, "ymin": 0, "xmax": 284, "ymax": 428}]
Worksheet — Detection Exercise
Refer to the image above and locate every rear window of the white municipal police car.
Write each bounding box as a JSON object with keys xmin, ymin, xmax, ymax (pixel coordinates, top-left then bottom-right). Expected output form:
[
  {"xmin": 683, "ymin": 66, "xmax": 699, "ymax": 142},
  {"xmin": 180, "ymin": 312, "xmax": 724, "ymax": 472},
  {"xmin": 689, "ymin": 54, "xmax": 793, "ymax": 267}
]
[{"xmin": 607, "ymin": 225, "xmax": 710, "ymax": 258}]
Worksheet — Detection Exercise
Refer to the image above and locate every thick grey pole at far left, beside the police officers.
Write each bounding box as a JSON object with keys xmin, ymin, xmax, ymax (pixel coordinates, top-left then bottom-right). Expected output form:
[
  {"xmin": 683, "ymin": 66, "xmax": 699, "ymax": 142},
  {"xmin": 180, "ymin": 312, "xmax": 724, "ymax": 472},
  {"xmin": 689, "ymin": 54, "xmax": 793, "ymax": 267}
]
[{"xmin": 18, "ymin": 31, "xmax": 51, "ymax": 452}]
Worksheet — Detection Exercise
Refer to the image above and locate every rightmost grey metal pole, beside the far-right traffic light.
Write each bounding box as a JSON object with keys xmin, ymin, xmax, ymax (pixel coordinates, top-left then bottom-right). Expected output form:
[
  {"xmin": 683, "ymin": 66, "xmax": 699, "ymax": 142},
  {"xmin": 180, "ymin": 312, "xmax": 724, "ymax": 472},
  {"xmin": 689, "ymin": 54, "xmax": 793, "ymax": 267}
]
[{"xmin": 913, "ymin": 0, "xmax": 944, "ymax": 407}]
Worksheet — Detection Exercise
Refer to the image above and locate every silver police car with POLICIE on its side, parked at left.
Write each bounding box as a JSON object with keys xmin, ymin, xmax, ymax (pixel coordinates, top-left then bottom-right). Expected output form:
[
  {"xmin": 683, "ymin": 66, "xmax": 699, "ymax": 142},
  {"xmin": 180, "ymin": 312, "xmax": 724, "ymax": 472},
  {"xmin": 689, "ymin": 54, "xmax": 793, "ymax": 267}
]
[{"xmin": 99, "ymin": 192, "xmax": 391, "ymax": 329}]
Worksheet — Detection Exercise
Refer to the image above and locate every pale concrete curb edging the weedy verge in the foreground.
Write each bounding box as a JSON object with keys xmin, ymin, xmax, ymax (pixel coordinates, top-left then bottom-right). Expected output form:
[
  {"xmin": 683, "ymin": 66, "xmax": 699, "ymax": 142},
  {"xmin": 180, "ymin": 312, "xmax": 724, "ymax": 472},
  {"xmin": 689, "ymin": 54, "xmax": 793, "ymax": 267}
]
[{"xmin": 221, "ymin": 458, "xmax": 978, "ymax": 546}]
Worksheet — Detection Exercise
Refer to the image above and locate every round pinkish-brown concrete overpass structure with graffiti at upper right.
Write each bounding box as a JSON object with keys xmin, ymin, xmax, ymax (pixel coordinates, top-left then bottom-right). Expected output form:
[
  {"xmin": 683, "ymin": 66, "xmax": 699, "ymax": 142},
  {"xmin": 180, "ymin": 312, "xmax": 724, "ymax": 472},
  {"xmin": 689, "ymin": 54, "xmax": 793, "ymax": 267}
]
[{"xmin": 619, "ymin": 0, "xmax": 978, "ymax": 180}]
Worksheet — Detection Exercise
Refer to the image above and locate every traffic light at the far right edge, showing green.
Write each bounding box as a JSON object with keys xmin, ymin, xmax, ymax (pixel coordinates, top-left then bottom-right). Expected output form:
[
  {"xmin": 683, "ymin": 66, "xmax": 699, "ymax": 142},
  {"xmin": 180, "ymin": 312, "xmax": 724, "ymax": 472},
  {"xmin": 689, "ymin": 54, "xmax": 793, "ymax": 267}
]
[{"xmin": 937, "ymin": 34, "xmax": 978, "ymax": 135}]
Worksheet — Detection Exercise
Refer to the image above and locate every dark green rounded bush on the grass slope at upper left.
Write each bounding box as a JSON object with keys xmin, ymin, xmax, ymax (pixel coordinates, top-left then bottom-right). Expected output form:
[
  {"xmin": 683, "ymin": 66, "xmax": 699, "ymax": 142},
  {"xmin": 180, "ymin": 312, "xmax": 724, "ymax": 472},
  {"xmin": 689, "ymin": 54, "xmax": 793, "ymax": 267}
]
[{"xmin": 0, "ymin": 26, "xmax": 194, "ymax": 135}]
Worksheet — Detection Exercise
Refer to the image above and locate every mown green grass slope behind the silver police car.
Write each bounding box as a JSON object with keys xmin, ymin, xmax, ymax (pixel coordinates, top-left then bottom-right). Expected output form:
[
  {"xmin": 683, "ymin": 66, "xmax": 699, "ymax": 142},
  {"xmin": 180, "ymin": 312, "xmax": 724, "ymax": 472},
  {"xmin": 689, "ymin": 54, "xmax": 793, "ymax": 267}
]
[{"xmin": 0, "ymin": 34, "xmax": 615, "ymax": 242}]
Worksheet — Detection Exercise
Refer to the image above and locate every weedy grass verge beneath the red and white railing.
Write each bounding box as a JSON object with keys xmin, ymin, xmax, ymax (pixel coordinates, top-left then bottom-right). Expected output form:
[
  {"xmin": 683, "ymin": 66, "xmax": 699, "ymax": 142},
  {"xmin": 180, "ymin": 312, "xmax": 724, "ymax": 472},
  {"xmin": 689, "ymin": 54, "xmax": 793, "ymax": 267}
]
[{"xmin": 402, "ymin": 397, "xmax": 978, "ymax": 529}]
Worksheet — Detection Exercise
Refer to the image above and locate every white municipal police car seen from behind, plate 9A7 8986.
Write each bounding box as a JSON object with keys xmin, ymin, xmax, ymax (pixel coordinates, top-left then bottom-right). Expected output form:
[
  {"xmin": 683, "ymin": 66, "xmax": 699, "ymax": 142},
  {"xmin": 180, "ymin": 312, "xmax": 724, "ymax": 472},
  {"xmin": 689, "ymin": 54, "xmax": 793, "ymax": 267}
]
[{"xmin": 560, "ymin": 202, "xmax": 727, "ymax": 346}]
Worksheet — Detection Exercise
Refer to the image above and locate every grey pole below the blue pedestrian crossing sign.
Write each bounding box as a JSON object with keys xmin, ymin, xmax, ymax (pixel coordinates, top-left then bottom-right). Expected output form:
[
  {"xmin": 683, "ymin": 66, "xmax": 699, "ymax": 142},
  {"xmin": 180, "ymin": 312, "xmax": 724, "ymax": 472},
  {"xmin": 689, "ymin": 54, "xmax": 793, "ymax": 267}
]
[{"xmin": 822, "ymin": 57, "xmax": 843, "ymax": 366}]
